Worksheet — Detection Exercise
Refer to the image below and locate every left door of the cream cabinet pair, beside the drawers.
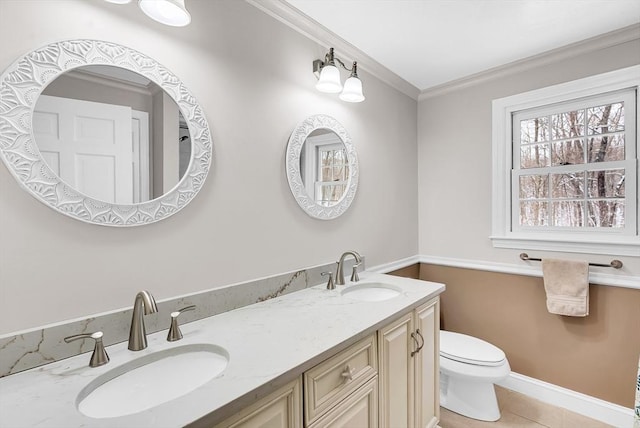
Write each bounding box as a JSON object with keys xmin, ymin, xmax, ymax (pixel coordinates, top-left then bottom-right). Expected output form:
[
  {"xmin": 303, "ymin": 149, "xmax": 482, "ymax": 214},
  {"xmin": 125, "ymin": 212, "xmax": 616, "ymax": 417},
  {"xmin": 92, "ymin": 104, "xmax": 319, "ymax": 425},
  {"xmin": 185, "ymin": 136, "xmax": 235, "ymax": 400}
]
[{"xmin": 378, "ymin": 313, "xmax": 417, "ymax": 428}]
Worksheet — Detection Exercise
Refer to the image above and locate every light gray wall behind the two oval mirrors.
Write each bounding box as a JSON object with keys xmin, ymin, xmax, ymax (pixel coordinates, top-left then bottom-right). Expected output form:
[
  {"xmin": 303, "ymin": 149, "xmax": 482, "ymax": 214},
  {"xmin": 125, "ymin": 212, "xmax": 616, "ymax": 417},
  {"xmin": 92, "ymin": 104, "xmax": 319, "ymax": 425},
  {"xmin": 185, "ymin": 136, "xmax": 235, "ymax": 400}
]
[{"xmin": 0, "ymin": 0, "xmax": 418, "ymax": 334}]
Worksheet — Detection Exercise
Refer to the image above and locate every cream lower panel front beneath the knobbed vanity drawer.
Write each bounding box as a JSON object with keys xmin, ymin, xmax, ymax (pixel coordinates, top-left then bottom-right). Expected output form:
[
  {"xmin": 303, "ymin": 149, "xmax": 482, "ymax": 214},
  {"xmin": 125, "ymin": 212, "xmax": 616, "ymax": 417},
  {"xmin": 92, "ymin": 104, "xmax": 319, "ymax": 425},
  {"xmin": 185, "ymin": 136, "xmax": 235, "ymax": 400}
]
[{"xmin": 309, "ymin": 376, "xmax": 378, "ymax": 428}]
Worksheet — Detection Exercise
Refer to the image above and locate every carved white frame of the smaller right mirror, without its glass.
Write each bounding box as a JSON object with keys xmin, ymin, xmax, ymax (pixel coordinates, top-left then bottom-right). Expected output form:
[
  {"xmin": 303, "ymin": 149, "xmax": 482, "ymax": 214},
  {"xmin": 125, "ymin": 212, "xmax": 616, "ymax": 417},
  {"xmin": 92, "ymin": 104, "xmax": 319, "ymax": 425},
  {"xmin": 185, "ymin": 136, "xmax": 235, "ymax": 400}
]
[{"xmin": 285, "ymin": 114, "xmax": 359, "ymax": 220}]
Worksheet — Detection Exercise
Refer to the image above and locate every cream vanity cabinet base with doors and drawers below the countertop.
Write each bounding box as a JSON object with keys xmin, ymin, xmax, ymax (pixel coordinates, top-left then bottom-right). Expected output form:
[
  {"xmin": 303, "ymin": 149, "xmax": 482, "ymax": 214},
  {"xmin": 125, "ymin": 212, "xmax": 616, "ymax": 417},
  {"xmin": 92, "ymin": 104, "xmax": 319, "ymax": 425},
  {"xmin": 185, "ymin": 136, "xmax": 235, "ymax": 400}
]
[{"xmin": 212, "ymin": 297, "xmax": 439, "ymax": 428}]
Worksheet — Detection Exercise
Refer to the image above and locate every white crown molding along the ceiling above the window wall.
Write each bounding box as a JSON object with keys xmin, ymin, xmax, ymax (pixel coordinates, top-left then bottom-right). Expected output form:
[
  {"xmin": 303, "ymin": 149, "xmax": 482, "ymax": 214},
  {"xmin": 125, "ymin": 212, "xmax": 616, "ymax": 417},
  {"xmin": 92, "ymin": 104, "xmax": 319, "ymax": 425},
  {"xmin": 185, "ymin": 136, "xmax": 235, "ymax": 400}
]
[{"xmin": 418, "ymin": 24, "xmax": 640, "ymax": 101}]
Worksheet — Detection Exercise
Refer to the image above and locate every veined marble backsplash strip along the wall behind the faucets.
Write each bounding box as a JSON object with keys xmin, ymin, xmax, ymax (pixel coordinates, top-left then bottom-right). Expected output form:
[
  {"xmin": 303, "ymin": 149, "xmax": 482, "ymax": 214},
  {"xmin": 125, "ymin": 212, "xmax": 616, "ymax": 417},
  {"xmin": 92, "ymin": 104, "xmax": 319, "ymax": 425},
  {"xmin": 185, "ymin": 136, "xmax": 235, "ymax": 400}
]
[{"xmin": 0, "ymin": 260, "xmax": 364, "ymax": 377}]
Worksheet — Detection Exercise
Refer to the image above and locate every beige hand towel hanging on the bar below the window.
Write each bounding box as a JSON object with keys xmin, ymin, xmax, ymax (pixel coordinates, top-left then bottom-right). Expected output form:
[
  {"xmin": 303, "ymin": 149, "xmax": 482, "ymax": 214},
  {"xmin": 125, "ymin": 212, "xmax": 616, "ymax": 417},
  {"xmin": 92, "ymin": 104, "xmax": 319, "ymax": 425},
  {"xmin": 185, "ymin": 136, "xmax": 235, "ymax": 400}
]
[{"xmin": 542, "ymin": 259, "xmax": 589, "ymax": 317}]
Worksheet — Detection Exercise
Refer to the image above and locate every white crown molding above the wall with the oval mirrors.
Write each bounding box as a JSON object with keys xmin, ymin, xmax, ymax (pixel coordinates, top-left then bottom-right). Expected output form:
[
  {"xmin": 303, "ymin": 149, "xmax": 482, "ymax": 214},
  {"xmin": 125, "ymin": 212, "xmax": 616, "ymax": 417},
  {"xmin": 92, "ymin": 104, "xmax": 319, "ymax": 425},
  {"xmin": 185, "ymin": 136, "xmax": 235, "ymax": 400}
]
[{"xmin": 245, "ymin": 0, "xmax": 420, "ymax": 100}]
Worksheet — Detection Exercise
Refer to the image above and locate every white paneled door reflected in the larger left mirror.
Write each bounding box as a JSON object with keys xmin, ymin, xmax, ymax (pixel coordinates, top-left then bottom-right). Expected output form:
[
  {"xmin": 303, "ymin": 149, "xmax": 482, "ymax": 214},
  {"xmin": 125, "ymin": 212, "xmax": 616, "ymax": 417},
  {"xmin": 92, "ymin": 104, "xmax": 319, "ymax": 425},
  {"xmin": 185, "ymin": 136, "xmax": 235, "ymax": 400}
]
[{"xmin": 33, "ymin": 95, "xmax": 133, "ymax": 204}]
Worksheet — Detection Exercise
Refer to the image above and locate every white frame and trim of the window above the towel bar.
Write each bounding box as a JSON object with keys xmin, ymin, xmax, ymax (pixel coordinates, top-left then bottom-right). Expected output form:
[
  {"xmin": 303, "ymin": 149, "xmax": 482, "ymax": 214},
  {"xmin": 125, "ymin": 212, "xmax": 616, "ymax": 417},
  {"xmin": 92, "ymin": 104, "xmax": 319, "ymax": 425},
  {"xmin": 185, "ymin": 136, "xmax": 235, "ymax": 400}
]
[{"xmin": 490, "ymin": 66, "xmax": 640, "ymax": 257}]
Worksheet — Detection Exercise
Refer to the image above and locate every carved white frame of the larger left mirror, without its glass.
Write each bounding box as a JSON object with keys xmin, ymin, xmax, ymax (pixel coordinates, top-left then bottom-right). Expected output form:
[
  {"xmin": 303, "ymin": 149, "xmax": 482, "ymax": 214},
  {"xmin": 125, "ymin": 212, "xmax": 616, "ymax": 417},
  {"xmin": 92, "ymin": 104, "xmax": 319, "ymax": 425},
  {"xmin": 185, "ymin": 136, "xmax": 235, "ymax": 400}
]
[{"xmin": 0, "ymin": 40, "xmax": 212, "ymax": 226}]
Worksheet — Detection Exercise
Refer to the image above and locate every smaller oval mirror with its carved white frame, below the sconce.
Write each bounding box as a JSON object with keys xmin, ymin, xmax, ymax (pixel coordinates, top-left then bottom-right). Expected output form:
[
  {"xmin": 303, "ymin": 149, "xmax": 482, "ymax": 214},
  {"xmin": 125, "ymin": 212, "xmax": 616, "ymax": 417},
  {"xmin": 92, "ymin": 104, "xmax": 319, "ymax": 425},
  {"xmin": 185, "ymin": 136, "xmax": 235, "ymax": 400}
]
[{"xmin": 286, "ymin": 115, "xmax": 358, "ymax": 220}]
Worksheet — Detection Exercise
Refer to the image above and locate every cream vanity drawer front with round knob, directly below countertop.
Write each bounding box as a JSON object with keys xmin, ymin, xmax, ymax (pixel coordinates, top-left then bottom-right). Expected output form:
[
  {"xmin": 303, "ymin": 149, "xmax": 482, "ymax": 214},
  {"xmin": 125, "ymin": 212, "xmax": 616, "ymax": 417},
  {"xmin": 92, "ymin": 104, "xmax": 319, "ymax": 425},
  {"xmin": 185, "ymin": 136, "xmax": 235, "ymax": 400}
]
[{"xmin": 304, "ymin": 335, "xmax": 378, "ymax": 425}]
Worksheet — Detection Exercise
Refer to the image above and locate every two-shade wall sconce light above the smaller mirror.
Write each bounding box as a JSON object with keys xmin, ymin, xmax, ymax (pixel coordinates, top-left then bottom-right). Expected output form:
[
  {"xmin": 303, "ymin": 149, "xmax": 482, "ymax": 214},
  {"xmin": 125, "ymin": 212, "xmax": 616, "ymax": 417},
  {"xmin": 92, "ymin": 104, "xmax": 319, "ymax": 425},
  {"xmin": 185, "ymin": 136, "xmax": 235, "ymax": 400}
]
[{"xmin": 313, "ymin": 48, "xmax": 364, "ymax": 103}]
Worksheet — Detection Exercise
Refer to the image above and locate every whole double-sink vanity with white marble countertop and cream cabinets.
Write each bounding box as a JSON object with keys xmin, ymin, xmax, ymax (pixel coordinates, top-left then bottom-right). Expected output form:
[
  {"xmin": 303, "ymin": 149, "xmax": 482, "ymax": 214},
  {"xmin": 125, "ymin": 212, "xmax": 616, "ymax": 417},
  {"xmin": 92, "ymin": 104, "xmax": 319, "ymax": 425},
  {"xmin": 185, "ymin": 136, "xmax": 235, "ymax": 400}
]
[{"xmin": 0, "ymin": 272, "xmax": 444, "ymax": 428}]
